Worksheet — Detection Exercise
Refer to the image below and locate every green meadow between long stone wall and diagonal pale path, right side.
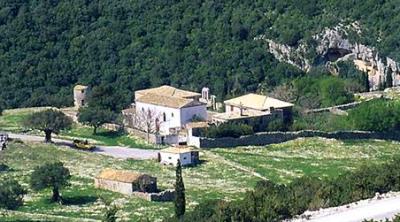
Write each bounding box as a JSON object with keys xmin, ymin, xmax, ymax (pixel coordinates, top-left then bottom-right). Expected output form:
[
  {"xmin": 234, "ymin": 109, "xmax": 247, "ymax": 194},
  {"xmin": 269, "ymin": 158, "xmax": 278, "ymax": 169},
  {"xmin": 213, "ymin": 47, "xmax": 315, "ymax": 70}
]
[{"xmin": 213, "ymin": 138, "xmax": 400, "ymax": 183}]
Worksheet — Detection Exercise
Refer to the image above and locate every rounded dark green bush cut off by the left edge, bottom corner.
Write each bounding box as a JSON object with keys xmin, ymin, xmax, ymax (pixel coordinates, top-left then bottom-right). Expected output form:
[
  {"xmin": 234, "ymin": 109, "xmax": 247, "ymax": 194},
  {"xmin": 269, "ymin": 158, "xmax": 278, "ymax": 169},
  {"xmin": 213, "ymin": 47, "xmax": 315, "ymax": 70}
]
[{"xmin": 0, "ymin": 179, "xmax": 26, "ymax": 210}]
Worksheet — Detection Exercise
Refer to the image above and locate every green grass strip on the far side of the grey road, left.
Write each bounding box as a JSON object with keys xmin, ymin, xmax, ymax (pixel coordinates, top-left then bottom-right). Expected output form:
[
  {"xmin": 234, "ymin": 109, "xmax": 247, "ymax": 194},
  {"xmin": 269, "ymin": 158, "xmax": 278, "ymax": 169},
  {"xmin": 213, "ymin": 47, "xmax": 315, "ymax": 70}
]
[{"xmin": 0, "ymin": 107, "xmax": 156, "ymax": 149}]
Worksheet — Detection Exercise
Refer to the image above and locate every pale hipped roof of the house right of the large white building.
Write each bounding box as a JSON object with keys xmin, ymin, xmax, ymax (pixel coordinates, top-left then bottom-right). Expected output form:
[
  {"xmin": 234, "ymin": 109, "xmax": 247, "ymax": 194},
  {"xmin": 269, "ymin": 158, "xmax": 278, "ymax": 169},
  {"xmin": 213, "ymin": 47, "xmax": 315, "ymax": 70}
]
[{"xmin": 224, "ymin": 93, "xmax": 293, "ymax": 110}]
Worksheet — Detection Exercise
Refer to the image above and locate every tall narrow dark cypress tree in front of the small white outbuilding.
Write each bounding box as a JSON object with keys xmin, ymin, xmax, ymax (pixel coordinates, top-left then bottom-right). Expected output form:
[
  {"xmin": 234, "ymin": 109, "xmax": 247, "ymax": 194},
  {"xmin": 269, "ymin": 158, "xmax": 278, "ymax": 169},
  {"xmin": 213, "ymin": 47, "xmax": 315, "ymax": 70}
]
[{"xmin": 174, "ymin": 160, "xmax": 186, "ymax": 220}]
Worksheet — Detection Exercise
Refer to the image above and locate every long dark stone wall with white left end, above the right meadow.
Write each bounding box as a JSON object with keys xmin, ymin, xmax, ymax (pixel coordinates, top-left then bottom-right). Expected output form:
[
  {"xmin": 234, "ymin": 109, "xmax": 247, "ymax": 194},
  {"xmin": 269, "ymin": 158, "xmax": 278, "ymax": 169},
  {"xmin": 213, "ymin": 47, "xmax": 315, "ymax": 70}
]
[{"xmin": 189, "ymin": 130, "xmax": 400, "ymax": 148}]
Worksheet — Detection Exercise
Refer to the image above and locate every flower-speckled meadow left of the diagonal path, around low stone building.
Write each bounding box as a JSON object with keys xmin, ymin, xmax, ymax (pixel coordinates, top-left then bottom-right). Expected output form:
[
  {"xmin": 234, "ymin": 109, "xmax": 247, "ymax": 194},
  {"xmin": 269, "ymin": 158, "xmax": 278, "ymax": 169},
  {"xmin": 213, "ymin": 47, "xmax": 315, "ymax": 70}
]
[{"xmin": 0, "ymin": 143, "xmax": 258, "ymax": 221}]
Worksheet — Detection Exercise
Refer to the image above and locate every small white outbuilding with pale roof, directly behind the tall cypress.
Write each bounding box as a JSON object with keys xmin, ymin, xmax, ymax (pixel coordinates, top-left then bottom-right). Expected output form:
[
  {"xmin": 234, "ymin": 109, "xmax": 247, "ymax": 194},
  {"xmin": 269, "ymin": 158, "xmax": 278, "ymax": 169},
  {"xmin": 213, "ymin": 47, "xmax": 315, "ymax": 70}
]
[{"xmin": 158, "ymin": 147, "xmax": 200, "ymax": 166}]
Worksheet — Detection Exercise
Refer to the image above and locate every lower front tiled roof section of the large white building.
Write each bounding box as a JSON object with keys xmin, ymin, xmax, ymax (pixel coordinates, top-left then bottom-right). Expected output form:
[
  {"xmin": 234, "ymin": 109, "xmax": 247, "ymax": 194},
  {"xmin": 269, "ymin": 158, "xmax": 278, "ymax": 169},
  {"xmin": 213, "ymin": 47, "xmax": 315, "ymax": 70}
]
[{"xmin": 136, "ymin": 93, "xmax": 205, "ymax": 108}]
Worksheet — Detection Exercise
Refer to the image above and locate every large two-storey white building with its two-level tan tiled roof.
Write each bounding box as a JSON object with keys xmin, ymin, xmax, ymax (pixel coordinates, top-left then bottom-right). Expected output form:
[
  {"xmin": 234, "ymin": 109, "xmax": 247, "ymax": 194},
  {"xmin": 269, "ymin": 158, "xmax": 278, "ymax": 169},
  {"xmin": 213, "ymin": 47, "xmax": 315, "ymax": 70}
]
[{"xmin": 135, "ymin": 86, "xmax": 207, "ymax": 135}]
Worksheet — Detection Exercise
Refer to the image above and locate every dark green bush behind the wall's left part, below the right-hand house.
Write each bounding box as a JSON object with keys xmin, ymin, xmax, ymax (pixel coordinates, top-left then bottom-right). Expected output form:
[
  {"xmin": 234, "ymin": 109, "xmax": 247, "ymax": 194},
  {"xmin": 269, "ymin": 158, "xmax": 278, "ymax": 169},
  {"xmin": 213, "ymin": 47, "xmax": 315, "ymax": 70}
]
[{"xmin": 202, "ymin": 123, "xmax": 254, "ymax": 138}]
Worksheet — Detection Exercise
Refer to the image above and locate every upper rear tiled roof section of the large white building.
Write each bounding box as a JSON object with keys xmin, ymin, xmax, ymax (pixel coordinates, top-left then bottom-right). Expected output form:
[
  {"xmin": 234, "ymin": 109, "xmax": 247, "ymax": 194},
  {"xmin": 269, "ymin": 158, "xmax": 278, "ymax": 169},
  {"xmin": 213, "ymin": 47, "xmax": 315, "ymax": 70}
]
[{"xmin": 135, "ymin": 85, "xmax": 201, "ymax": 98}]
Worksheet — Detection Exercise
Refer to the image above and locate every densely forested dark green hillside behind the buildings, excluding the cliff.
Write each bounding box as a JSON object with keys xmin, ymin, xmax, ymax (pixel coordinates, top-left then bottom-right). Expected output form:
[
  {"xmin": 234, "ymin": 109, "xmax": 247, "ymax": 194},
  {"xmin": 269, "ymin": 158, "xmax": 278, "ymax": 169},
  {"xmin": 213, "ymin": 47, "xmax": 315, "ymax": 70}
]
[{"xmin": 0, "ymin": 0, "xmax": 400, "ymax": 108}]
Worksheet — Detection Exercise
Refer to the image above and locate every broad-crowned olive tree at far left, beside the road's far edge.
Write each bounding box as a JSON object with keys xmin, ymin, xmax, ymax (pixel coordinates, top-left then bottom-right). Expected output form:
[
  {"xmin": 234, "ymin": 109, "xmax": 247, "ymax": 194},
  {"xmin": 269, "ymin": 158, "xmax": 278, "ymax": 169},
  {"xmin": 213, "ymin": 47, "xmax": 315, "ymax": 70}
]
[{"xmin": 25, "ymin": 109, "xmax": 72, "ymax": 143}]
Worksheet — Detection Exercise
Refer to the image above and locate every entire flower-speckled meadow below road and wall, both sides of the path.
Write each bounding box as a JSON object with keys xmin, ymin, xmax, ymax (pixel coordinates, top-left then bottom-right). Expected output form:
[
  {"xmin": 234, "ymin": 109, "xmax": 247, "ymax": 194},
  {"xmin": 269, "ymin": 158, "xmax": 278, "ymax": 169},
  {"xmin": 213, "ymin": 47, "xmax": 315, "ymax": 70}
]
[{"xmin": 0, "ymin": 138, "xmax": 400, "ymax": 221}]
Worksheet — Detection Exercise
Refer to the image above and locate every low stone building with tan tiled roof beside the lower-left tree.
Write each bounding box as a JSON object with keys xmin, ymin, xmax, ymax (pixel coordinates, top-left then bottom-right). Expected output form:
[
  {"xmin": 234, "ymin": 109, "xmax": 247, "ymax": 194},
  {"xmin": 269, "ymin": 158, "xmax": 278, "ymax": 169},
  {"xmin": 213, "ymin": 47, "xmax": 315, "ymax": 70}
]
[{"xmin": 94, "ymin": 169, "xmax": 158, "ymax": 194}]
